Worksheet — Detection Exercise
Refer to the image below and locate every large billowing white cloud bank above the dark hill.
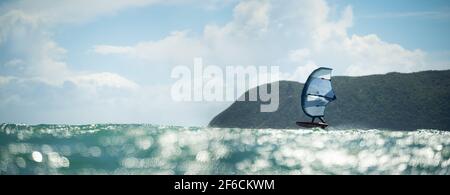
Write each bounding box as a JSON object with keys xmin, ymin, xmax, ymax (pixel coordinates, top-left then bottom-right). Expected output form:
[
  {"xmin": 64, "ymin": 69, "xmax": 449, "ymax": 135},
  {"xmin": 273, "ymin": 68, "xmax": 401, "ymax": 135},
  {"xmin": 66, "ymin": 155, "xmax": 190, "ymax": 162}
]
[{"xmin": 94, "ymin": 0, "xmax": 445, "ymax": 79}]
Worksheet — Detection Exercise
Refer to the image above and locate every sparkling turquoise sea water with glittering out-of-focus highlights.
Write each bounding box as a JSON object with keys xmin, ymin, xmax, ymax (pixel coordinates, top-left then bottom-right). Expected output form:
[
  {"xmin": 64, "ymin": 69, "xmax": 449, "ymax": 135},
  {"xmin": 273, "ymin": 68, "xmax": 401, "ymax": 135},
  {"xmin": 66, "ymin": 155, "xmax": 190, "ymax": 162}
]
[{"xmin": 0, "ymin": 124, "xmax": 450, "ymax": 174}]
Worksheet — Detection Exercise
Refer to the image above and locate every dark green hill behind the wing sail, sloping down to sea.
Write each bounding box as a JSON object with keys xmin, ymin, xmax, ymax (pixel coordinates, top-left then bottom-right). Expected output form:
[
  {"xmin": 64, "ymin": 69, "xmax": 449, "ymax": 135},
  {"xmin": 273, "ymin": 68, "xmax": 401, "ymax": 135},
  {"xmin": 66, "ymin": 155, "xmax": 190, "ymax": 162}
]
[{"xmin": 209, "ymin": 70, "xmax": 450, "ymax": 130}]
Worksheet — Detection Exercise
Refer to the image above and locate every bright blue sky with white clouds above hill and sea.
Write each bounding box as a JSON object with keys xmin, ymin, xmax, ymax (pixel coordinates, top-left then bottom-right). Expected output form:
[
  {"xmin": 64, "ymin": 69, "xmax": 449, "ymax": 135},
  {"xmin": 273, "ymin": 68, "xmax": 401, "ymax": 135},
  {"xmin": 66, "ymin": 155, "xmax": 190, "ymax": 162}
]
[{"xmin": 0, "ymin": 0, "xmax": 450, "ymax": 126}]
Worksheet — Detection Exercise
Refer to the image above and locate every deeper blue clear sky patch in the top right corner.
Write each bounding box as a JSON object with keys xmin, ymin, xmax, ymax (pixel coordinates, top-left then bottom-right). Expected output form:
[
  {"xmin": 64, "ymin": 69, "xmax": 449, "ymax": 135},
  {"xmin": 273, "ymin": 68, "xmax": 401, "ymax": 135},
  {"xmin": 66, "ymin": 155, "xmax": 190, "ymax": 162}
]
[{"xmin": 335, "ymin": 0, "xmax": 450, "ymax": 51}]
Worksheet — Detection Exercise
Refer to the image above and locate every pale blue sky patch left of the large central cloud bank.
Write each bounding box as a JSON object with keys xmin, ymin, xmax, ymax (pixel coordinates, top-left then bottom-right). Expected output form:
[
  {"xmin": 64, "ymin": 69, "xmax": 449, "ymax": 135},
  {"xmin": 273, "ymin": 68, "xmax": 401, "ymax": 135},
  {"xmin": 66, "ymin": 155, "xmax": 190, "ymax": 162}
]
[{"xmin": 55, "ymin": 4, "xmax": 233, "ymax": 84}]
